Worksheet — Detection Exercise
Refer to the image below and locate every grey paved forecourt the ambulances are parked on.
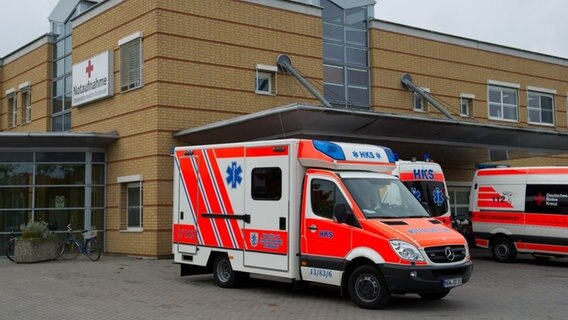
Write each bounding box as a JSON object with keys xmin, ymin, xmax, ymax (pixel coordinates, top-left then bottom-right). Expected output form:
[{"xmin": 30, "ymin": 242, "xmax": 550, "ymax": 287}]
[{"xmin": 0, "ymin": 249, "xmax": 568, "ymax": 320}]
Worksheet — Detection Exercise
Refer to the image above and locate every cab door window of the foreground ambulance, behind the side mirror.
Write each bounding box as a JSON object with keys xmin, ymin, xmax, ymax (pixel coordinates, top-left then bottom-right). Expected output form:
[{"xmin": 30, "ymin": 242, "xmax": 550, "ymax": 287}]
[{"xmin": 310, "ymin": 179, "xmax": 347, "ymax": 219}]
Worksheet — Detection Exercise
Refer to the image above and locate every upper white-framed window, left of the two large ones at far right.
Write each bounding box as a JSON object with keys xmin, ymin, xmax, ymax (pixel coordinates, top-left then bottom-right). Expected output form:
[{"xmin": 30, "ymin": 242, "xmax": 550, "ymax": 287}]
[{"xmin": 487, "ymin": 84, "xmax": 519, "ymax": 121}]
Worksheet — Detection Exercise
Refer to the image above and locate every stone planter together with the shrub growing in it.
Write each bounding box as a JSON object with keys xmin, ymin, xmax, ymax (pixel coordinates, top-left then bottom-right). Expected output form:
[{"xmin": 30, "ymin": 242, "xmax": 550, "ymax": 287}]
[{"xmin": 14, "ymin": 221, "xmax": 59, "ymax": 263}]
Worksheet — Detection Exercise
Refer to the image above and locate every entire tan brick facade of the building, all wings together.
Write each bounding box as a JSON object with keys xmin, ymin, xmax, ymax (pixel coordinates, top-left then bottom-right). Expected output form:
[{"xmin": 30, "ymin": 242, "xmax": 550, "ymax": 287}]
[{"xmin": 0, "ymin": 0, "xmax": 568, "ymax": 256}]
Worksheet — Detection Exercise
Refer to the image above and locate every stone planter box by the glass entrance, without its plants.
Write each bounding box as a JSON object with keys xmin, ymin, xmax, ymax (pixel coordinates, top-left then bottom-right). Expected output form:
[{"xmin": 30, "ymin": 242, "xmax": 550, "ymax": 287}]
[{"xmin": 14, "ymin": 237, "xmax": 60, "ymax": 263}]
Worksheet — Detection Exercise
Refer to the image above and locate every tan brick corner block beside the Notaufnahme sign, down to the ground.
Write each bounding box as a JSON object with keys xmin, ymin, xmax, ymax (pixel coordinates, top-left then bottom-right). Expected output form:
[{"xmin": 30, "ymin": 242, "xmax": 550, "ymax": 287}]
[{"xmin": 67, "ymin": 0, "xmax": 323, "ymax": 256}]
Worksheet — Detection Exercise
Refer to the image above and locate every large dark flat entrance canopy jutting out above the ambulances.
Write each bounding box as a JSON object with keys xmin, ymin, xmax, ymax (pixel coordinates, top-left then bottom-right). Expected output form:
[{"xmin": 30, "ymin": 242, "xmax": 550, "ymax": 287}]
[{"xmin": 174, "ymin": 104, "xmax": 568, "ymax": 165}]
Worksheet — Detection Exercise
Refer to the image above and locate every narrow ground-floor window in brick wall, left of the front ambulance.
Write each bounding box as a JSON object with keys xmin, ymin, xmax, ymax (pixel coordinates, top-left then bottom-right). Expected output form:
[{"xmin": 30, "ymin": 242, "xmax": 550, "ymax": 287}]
[{"xmin": 117, "ymin": 175, "xmax": 144, "ymax": 231}]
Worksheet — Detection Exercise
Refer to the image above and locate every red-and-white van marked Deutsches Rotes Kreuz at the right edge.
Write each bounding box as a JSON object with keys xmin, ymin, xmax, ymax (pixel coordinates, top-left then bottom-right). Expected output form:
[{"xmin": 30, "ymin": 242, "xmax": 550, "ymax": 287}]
[{"xmin": 469, "ymin": 167, "xmax": 568, "ymax": 262}]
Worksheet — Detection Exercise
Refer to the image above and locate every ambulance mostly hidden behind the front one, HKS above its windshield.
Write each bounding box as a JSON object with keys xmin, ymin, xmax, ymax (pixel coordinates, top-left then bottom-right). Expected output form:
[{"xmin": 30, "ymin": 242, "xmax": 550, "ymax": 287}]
[{"xmin": 392, "ymin": 160, "xmax": 452, "ymax": 227}]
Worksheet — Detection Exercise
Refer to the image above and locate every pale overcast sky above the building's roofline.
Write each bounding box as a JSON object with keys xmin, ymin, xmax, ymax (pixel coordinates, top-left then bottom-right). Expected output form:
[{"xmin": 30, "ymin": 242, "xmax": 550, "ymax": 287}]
[{"xmin": 0, "ymin": 0, "xmax": 568, "ymax": 58}]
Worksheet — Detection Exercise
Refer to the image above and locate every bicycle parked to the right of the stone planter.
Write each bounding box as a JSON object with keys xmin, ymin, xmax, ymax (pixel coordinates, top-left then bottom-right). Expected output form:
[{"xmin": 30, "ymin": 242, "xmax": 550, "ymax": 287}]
[{"xmin": 59, "ymin": 224, "xmax": 101, "ymax": 261}]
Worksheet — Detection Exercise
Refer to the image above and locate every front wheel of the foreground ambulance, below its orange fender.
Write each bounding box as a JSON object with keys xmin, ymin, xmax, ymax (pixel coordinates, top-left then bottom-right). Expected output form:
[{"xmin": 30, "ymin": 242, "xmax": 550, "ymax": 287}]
[{"xmin": 347, "ymin": 265, "xmax": 390, "ymax": 309}]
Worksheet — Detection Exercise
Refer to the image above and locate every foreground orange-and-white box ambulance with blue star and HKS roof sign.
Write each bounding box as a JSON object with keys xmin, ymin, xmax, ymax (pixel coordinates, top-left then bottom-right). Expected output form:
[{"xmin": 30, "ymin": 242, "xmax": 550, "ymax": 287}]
[{"xmin": 172, "ymin": 139, "xmax": 473, "ymax": 309}]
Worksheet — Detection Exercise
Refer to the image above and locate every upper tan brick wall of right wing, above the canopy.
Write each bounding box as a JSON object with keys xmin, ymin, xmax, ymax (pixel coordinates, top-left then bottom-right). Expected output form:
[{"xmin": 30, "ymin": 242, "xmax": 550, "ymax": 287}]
[{"xmin": 371, "ymin": 29, "xmax": 568, "ymax": 132}]
